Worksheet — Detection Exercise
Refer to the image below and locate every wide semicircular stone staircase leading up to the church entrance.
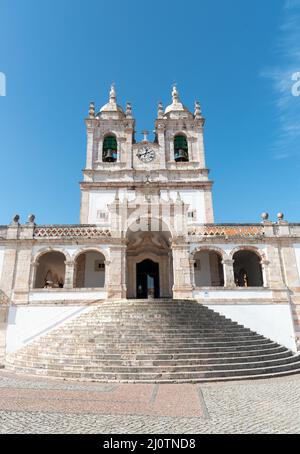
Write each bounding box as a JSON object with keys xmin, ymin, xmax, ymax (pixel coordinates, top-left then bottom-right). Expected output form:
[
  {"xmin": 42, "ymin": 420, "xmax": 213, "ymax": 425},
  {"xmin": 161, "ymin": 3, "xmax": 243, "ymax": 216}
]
[{"xmin": 6, "ymin": 300, "xmax": 300, "ymax": 383}]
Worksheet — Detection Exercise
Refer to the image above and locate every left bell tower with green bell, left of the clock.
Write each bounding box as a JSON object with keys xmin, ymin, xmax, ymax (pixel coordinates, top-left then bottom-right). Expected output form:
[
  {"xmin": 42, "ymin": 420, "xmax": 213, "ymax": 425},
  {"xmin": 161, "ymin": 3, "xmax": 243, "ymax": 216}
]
[{"xmin": 80, "ymin": 85, "xmax": 135, "ymax": 224}]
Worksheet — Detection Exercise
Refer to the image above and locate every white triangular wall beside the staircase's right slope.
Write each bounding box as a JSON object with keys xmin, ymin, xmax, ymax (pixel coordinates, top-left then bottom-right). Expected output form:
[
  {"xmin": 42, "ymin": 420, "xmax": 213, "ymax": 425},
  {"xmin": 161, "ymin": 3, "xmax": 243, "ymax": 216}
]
[{"xmin": 205, "ymin": 304, "xmax": 297, "ymax": 352}]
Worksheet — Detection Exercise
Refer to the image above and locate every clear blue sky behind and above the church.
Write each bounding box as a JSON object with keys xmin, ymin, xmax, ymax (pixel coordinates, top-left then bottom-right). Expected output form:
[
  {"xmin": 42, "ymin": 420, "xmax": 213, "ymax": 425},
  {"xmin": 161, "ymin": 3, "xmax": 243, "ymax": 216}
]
[{"xmin": 0, "ymin": 0, "xmax": 300, "ymax": 224}]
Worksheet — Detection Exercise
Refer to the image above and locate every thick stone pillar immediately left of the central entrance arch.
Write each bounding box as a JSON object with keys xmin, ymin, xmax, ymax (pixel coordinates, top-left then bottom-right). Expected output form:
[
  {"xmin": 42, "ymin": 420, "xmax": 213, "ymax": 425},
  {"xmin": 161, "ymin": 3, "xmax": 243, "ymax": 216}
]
[{"xmin": 106, "ymin": 245, "xmax": 126, "ymax": 300}]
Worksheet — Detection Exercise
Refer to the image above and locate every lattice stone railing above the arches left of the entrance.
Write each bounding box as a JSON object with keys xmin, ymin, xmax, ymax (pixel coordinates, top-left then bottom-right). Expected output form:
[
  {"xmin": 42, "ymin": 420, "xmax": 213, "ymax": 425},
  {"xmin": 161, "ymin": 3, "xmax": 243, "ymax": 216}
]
[{"xmin": 33, "ymin": 225, "xmax": 111, "ymax": 238}]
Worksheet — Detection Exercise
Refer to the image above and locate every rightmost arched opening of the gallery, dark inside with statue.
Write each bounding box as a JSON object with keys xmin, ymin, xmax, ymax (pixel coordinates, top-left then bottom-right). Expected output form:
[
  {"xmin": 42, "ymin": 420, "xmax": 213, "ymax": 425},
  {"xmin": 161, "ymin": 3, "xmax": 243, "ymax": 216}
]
[{"xmin": 233, "ymin": 250, "xmax": 264, "ymax": 287}]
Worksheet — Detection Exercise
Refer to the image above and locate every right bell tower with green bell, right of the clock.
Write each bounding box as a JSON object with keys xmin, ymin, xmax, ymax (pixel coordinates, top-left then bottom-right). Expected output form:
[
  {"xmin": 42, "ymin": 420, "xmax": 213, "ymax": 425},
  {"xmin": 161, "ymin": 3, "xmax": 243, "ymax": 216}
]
[{"xmin": 155, "ymin": 85, "xmax": 214, "ymax": 224}]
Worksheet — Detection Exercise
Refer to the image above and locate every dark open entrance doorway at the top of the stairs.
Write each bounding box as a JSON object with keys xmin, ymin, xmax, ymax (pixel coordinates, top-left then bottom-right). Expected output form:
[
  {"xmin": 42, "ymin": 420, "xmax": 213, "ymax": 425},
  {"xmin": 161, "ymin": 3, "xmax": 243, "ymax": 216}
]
[{"xmin": 136, "ymin": 259, "xmax": 160, "ymax": 299}]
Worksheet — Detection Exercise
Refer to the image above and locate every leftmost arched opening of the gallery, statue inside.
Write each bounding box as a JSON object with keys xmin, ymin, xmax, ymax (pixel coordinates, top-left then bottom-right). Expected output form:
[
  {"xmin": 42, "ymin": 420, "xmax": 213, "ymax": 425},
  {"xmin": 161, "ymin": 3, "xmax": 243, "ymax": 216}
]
[{"xmin": 34, "ymin": 251, "xmax": 66, "ymax": 288}]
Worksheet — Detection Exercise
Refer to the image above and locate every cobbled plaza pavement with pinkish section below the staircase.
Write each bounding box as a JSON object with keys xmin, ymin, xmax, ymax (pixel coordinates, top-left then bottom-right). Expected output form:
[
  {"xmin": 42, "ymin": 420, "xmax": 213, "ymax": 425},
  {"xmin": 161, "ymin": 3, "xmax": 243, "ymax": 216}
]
[{"xmin": 0, "ymin": 370, "xmax": 300, "ymax": 434}]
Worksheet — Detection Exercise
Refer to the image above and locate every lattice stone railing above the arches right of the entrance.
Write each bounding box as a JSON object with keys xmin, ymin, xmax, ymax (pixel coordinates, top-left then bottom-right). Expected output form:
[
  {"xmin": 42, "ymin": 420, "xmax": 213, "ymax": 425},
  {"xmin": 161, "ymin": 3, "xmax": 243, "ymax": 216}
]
[{"xmin": 188, "ymin": 225, "xmax": 264, "ymax": 237}]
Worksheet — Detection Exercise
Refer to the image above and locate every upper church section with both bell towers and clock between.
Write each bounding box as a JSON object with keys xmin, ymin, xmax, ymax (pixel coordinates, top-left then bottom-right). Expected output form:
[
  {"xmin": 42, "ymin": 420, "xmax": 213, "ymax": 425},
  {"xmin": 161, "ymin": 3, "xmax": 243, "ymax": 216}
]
[{"xmin": 80, "ymin": 85, "xmax": 214, "ymax": 227}]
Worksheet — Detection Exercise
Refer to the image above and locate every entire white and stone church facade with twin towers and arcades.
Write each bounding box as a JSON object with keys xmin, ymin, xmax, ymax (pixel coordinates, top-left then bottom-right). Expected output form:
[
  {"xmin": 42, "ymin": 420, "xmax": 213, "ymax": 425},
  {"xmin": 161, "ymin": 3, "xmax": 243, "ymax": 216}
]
[{"xmin": 0, "ymin": 86, "xmax": 300, "ymax": 359}]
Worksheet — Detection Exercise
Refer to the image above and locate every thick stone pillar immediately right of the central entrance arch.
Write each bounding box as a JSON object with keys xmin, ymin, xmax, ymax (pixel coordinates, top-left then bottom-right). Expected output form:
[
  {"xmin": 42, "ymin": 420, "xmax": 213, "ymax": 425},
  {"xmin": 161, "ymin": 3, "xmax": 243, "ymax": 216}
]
[{"xmin": 171, "ymin": 243, "xmax": 193, "ymax": 299}]
